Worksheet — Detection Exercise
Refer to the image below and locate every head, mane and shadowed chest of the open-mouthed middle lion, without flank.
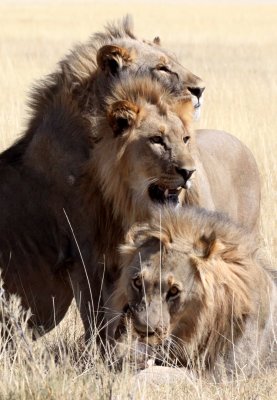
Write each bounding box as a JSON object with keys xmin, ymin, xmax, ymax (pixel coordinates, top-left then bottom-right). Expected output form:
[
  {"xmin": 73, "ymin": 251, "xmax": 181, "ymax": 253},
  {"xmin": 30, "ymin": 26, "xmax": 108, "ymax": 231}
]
[{"xmin": 69, "ymin": 74, "xmax": 196, "ymax": 336}]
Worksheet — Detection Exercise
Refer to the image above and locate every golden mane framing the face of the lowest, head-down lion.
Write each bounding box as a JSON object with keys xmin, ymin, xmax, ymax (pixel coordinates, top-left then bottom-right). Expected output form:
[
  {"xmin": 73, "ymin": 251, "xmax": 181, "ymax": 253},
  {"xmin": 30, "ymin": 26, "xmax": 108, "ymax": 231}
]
[{"xmin": 118, "ymin": 207, "xmax": 275, "ymax": 368}]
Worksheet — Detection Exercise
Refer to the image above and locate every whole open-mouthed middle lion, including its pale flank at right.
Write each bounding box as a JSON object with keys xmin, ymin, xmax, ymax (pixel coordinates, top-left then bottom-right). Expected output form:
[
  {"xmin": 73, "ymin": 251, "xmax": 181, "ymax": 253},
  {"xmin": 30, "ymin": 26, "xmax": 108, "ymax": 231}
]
[{"xmin": 68, "ymin": 74, "xmax": 259, "ymax": 344}]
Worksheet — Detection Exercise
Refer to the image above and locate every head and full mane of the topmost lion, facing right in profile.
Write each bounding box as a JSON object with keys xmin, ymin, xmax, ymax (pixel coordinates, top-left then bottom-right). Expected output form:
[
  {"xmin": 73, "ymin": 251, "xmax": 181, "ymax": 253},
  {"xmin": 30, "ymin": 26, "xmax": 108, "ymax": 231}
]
[{"xmin": 8, "ymin": 16, "xmax": 205, "ymax": 198}]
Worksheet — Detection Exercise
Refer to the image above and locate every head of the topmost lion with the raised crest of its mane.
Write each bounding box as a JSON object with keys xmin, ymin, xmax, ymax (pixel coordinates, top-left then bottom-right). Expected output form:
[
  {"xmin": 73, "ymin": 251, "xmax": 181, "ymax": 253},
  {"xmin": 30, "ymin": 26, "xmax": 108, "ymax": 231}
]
[{"xmin": 61, "ymin": 17, "xmax": 205, "ymax": 119}]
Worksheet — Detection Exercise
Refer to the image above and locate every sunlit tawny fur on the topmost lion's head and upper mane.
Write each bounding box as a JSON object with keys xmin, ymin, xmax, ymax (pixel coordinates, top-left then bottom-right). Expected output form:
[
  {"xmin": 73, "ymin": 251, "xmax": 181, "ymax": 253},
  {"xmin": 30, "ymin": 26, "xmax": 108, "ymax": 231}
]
[{"xmin": 25, "ymin": 17, "xmax": 203, "ymax": 148}]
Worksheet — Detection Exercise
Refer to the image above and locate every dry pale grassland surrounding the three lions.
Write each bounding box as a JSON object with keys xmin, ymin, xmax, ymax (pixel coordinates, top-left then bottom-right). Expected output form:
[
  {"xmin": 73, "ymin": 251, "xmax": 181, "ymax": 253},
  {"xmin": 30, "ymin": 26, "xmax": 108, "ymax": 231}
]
[{"xmin": 0, "ymin": 1, "xmax": 277, "ymax": 399}]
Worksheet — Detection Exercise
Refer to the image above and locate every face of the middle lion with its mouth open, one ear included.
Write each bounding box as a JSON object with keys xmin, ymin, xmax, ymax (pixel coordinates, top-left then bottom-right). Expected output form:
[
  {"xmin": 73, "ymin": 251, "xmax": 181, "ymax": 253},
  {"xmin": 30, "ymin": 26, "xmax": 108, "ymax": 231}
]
[{"xmin": 93, "ymin": 90, "xmax": 195, "ymax": 213}]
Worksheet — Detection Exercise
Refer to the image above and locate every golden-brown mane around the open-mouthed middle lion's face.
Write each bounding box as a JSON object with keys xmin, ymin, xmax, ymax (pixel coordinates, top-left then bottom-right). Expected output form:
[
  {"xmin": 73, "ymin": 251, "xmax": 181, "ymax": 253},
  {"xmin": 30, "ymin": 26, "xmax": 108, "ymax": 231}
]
[{"xmin": 81, "ymin": 76, "xmax": 194, "ymax": 229}]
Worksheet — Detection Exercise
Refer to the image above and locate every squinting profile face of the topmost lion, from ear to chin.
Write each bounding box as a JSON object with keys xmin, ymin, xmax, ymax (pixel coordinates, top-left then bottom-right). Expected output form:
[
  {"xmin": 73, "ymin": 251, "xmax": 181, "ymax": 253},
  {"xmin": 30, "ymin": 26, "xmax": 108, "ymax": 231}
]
[{"xmin": 97, "ymin": 39, "xmax": 205, "ymax": 119}]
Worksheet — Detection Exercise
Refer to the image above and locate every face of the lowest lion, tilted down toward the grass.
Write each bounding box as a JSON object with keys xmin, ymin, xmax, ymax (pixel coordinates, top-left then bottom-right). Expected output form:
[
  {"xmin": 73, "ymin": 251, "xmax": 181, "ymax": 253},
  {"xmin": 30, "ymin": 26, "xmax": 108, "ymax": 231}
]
[{"xmin": 117, "ymin": 238, "xmax": 199, "ymax": 345}]
